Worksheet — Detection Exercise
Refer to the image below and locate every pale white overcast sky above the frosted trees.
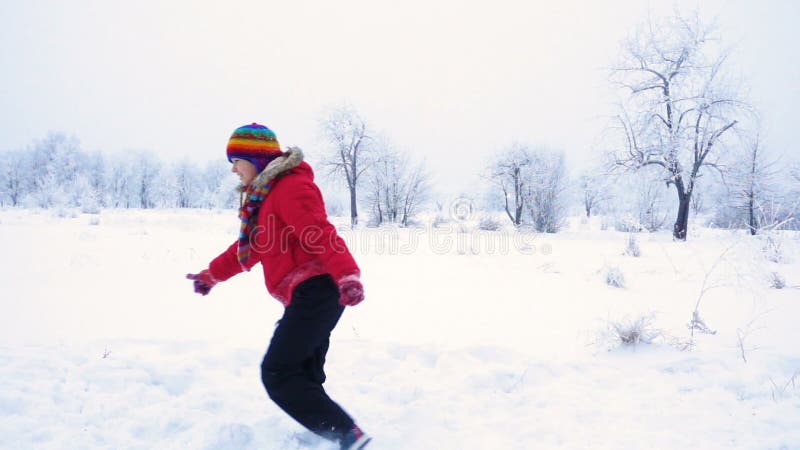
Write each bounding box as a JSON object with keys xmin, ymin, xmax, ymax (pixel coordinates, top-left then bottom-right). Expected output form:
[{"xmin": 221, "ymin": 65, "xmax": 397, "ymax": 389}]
[{"xmin": 0, "ymin": 0, "xmax": 800, "ymax": 196}]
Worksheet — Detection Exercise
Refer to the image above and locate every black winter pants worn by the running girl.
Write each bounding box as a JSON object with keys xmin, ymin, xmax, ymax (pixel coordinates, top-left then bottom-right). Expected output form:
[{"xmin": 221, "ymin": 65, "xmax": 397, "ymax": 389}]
[{"xmin": 261, "ymin": 275, "xmax": 353, "ymax": 439}]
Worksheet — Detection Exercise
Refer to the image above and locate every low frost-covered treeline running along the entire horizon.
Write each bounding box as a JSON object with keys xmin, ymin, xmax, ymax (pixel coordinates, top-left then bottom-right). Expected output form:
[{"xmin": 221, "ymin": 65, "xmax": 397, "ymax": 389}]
[{"xmin": 0, "ymin": 127, "xmax": 800, "ymax": 234}]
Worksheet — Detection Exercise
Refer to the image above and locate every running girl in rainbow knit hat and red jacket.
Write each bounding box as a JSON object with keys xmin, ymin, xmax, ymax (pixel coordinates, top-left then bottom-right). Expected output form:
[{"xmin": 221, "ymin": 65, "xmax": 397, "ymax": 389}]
[{"xmin": 186, "ymin": 123, "xmax": 370, "ymax": 450}]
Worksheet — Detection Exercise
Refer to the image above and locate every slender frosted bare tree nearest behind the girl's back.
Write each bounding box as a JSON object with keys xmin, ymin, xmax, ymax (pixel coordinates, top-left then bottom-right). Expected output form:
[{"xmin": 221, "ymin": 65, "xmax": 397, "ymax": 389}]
[{"xmin": 321, "ymin": 105, "xmax": 371, "ymax": 227}]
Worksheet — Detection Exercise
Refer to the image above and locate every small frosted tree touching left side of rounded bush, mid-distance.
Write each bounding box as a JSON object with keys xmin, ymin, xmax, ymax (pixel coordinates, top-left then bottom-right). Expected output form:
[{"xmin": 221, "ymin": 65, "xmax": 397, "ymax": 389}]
[{"xmin": 486, "ymin": 143, "xmax": 532, "ymax": 226}]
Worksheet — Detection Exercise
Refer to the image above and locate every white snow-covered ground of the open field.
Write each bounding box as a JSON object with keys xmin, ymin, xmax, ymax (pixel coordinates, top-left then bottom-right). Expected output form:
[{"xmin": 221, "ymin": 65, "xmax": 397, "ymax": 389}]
[{"xmin": 0, "ymin": 210, "xmax": 800, "ymax": 450}]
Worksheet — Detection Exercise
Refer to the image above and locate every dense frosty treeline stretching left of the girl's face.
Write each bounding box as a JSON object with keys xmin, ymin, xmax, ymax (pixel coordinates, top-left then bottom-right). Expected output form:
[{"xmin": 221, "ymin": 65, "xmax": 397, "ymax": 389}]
[{"xmin": 0, "ymin": 133, "xmax": 238, "ymax": 213}]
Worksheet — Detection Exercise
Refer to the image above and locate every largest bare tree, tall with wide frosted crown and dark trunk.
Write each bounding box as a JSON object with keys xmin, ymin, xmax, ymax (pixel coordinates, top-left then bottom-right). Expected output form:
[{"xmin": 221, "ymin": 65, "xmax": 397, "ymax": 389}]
[{"xmin": 611, "ymin": 13, "xmax": 749, "ymax": 240}]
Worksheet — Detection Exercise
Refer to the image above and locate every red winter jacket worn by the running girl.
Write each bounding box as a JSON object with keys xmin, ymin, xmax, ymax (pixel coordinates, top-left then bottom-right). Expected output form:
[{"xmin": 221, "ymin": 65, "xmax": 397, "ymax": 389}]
[{"xmin": 209, "ymin": 162, "xmax": 360, "ymax": 306}]
